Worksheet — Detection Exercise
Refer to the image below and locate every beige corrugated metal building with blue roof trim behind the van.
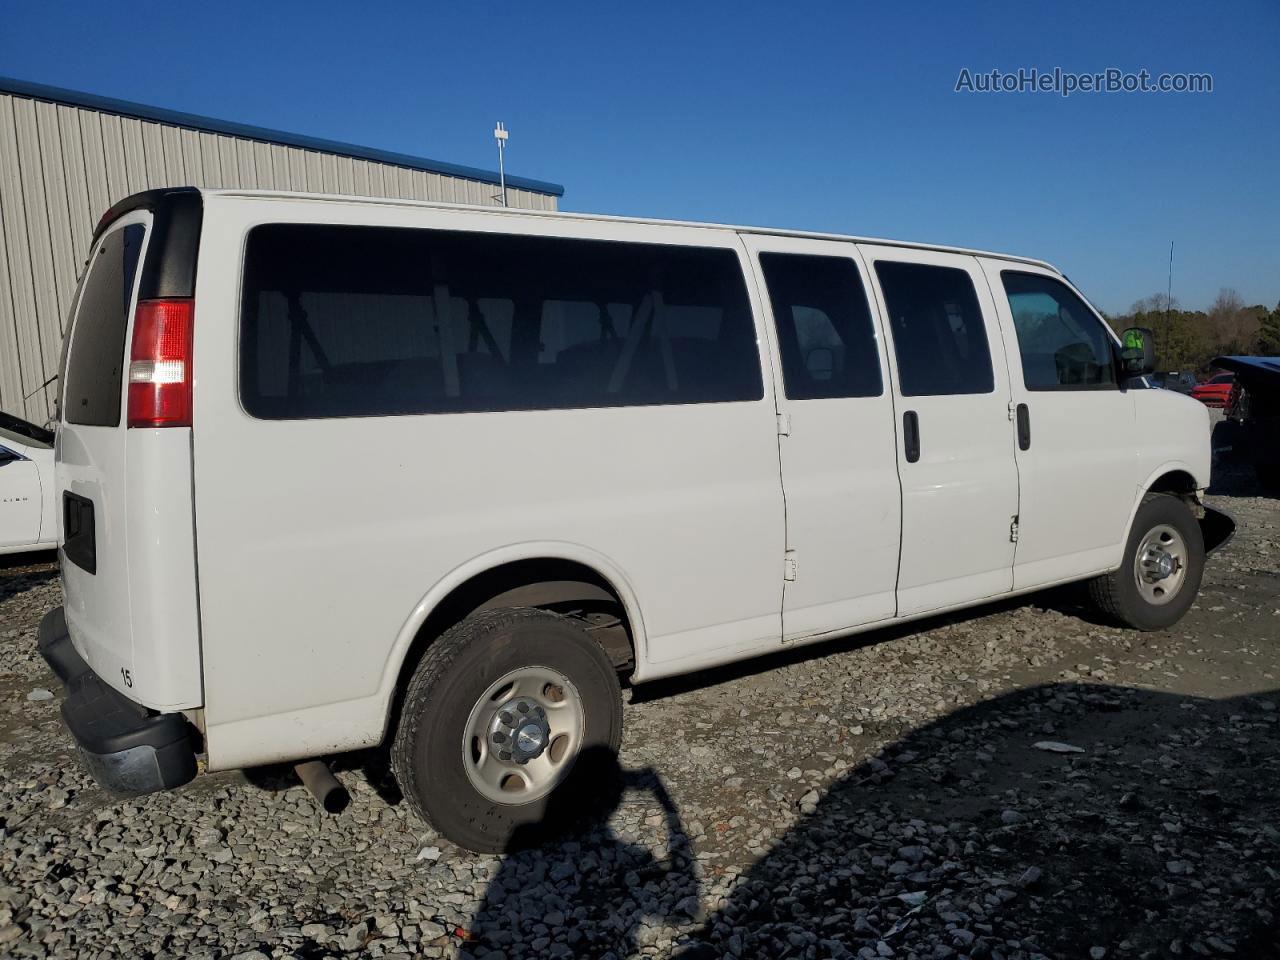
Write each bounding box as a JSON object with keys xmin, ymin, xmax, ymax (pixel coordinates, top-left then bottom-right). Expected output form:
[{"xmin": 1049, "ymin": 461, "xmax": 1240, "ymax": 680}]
[{"xmin": 0, "ymin": 77, "xmax": 564, "ymax": 422}]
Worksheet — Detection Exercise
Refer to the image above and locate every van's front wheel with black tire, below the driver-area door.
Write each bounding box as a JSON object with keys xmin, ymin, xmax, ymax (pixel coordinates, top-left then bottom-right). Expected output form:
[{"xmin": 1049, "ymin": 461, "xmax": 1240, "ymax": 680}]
[{"xmin": 1089, "ymin": 493, "xmax": 1204, "ymax": 630}]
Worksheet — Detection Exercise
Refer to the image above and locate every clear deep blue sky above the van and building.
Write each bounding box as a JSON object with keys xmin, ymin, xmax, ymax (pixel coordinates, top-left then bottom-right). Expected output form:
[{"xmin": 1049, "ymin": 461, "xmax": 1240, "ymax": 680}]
[{"xmin": 0, "ymin": 0, "xmax": 1280, "ymax": 311}]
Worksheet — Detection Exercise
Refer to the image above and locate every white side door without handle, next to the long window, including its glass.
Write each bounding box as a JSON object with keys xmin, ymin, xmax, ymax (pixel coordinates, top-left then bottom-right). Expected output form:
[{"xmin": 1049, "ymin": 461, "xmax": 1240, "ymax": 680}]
[{"xmin": 744, "ymin": 234, "xmax": 901, "ymax": 640}]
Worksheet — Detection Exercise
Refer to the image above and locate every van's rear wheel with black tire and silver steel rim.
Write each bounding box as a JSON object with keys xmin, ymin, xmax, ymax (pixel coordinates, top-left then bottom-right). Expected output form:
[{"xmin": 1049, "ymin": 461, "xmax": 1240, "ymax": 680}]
[{"xmin": 392, "ymin": 608, "xmax": 622, "ymax": 852}]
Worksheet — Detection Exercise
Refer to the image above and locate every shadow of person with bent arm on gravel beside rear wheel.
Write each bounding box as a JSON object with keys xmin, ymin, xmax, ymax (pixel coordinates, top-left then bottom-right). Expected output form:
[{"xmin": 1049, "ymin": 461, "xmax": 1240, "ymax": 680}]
[{"xmin": 458, "ymin": 750, "xmax": 699, "ymax": 960}]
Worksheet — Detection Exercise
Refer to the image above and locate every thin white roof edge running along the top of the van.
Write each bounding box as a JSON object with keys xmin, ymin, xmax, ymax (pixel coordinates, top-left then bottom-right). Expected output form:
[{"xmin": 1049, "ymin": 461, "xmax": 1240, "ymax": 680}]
[{"xmin": 200, "ymin": 188, "xmax": 1061, "ymax": 275}]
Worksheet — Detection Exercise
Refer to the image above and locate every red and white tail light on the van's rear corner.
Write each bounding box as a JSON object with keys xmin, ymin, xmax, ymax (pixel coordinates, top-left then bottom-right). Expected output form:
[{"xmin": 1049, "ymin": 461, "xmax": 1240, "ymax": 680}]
[{"xmin": 128, "ymin": 297, "xmax": 196, "ymax": 426}]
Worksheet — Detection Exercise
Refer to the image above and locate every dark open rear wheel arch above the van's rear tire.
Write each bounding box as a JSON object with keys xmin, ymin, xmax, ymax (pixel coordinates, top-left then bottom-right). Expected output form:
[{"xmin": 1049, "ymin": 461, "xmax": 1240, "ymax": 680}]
[{"xmin": 384, "ymin": 557, "xmax": 637, "ymax": 736}]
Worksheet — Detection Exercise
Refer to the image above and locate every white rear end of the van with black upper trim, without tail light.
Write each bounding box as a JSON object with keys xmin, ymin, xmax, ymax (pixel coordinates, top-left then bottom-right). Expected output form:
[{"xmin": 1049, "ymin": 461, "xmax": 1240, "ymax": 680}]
[{"xmin": 55, "ymin": 191, "xmax": 201, "ymax": 710}]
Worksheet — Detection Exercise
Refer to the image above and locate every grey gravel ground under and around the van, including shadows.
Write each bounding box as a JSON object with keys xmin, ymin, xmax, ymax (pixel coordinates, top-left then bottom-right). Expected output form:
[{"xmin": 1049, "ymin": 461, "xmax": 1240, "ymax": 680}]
[{"xmin": 0, "ymin": 455, "xmax": 1280, "ymax": 960}]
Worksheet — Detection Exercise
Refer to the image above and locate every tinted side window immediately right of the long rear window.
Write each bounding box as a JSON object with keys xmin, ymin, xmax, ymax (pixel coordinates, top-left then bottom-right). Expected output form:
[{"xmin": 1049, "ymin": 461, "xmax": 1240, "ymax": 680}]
[{"xmin": 760, "ymin": 253, "xmax": 883, "ymax": 399}]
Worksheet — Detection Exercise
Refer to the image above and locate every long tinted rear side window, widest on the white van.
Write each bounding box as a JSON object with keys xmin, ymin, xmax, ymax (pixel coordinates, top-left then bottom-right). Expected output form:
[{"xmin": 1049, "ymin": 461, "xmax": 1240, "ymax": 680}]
[{"xmin": 241, "ymin": 224, "xmax": 764, "ymax": 420}]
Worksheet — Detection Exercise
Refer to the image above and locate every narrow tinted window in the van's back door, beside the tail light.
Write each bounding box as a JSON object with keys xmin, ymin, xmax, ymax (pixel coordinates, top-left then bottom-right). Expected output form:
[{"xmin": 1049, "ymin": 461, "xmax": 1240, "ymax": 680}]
[{"xmin": 61, "ymin": 224, "xmax": 146, "ymax": 426}]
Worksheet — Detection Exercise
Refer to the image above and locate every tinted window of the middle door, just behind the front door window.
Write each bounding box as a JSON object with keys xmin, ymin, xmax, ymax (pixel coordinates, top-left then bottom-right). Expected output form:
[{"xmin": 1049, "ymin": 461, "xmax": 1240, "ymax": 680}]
[{"xmin": 876, "ymin": 260, "xmax": 995, "ymax": 397}]
